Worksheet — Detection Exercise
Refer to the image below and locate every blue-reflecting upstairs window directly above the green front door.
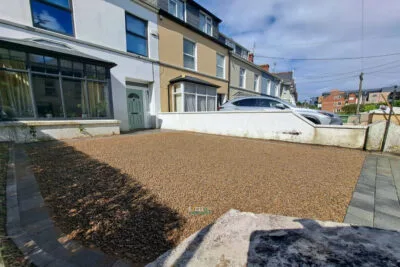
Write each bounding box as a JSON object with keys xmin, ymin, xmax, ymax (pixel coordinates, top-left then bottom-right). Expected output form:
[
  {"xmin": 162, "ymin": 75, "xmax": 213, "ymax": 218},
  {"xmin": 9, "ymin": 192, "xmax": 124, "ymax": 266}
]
[{"xmin": 126, "ymin": 14, "xmax": 147, "ymax": 57}]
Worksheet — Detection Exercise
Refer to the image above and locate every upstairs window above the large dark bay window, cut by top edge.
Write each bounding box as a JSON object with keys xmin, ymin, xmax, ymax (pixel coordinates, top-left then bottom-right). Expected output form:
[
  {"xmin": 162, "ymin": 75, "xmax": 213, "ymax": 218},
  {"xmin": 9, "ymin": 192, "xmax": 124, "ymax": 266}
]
[{"xmin": 31, "ymin": 0, "xmax": 74, "ymax": 36}]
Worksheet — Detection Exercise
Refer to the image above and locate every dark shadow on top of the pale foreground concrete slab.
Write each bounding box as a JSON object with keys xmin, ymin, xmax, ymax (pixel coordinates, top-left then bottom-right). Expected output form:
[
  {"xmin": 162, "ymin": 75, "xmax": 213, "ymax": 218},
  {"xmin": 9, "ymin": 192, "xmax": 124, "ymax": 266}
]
[{"xmin": 247, "ymin": 219, "xmax": 400, "ymax": 267}]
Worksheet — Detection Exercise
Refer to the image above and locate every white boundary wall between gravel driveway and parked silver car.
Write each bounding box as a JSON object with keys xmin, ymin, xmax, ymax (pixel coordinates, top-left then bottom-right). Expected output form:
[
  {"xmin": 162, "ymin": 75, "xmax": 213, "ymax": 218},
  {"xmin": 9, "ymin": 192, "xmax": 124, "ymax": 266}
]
[{"xmin": 159, "ymin": 111, "xmax": 367, "ymax": 149}]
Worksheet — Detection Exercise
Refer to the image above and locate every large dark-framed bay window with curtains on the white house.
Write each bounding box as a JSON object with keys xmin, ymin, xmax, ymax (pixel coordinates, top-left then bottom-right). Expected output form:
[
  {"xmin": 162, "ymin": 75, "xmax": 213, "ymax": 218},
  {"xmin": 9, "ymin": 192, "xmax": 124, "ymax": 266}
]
[{"xmin": 0, "ymin": 48, "xmax": 111, "ymax": 120}]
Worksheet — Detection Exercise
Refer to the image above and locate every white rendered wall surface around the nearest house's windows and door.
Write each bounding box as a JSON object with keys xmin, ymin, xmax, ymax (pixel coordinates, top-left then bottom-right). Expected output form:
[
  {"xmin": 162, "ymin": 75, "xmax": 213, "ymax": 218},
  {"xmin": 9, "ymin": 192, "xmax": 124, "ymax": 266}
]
[{"xmin": 0, "ymin": 0, "xmax": 160, "ymax": 131}]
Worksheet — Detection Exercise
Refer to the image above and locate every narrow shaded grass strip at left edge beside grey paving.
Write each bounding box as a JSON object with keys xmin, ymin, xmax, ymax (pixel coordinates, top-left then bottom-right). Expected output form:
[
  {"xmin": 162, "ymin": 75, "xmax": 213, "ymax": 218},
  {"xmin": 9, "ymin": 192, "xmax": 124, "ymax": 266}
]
[{"xmin": 0, "ymin": 143, "xmax": 27, "ymax": 267}]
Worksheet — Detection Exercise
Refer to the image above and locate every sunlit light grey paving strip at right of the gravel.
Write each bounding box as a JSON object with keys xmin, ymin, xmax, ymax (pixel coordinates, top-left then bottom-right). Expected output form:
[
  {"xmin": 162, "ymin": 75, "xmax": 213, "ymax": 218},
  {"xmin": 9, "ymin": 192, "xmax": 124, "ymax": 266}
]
[{"xmin": 344, "ymin": 154, "xmax": 400, "ymax": 230}]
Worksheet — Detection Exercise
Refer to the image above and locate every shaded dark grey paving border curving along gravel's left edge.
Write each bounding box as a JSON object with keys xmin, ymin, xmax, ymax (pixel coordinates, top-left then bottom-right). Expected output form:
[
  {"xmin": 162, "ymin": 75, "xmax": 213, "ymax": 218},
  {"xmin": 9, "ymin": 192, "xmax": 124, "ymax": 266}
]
[{"xmin": 7, "ymin": 147, "xmax": 130, "ymax": 267}]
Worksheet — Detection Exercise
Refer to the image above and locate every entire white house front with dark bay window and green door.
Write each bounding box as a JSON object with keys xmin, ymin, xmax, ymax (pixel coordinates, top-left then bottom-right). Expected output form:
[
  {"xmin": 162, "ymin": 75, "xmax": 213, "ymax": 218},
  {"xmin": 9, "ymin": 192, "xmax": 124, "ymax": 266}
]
[{"xmin": 0, "ymin": 0, "xmax": 160, "ymax": 131}]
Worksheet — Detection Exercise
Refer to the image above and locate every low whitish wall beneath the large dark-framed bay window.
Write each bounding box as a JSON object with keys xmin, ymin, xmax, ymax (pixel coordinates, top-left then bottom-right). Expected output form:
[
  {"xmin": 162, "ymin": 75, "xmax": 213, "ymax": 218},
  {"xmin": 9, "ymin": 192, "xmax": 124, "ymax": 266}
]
[{"xmin": 0, "ymin": 120, "xmax": 120, "ymax": 143}]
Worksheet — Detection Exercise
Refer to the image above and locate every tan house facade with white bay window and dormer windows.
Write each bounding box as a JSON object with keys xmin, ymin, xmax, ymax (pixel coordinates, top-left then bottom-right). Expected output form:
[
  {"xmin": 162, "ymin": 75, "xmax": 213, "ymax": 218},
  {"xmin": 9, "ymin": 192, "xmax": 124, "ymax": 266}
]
[{"xmin": 158, "ymin": 0, "xmax": 230, "ymax": 112}]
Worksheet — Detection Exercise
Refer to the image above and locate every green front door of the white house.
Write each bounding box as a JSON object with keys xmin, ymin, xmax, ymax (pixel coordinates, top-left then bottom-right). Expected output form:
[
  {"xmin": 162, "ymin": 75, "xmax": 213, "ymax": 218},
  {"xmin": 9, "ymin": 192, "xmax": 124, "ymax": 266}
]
[{"xmin": 126, "ymin": 89, "xmax": 144, "ymax": 130}]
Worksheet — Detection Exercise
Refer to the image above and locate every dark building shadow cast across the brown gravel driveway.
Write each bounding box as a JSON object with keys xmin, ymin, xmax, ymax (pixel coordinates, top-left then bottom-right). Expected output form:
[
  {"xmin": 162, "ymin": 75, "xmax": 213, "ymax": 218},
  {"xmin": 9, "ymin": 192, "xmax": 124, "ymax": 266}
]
[{"xmin": 25, "ymin": 142, "xmax": 184, "ymax": 265}]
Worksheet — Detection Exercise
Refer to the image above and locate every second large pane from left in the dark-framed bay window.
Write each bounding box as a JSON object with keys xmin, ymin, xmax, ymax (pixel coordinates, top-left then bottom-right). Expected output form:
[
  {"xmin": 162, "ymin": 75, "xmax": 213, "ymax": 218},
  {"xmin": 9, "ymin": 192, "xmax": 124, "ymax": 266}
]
[{"xmin": 32, "ymin": 75, "xmax": 64, "ymax": 118}]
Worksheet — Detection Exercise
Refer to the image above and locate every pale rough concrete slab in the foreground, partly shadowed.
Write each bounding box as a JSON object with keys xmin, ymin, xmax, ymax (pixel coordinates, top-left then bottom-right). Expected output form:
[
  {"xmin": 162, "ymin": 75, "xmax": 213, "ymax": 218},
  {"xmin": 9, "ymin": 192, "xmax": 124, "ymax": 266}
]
[{"xmin": 148, "ymin": 210, "xmax": 400, "ymax": 267}]
